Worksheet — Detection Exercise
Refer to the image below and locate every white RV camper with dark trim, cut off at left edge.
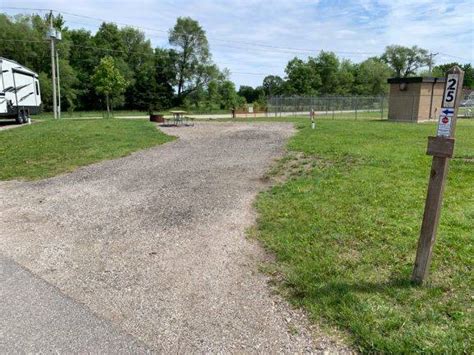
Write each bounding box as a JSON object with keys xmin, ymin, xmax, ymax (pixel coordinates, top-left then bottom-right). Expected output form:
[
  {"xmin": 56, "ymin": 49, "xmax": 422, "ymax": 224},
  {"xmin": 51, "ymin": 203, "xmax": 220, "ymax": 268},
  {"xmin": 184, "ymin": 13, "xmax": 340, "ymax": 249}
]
[{"xmin": 0, "ymin": 57, "xmax": 41, "ymax": 124}]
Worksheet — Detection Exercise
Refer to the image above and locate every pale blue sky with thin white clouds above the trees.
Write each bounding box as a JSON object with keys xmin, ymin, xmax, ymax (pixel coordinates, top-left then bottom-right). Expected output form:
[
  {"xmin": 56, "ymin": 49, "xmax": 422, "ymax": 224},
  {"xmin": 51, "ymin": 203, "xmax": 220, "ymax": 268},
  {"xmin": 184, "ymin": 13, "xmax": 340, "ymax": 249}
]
[{"xmin": 0, "ymin": 0, "xmax": 474, "ymax": 87}]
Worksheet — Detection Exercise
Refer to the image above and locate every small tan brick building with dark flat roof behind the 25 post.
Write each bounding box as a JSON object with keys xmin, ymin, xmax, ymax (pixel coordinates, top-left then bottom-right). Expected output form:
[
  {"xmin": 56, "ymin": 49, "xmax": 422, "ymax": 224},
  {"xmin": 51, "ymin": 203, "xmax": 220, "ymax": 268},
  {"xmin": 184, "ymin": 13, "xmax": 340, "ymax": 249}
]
[{"xmin": 387, "ymin": 77, "xmax": 445, "ymax": 122}]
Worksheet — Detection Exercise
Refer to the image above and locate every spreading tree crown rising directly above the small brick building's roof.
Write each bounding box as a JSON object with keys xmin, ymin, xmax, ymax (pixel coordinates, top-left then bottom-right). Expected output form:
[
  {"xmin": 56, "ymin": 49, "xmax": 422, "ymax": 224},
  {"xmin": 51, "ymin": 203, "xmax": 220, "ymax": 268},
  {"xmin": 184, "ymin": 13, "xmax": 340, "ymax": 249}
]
[{"xmin": 381, "ymin": 45, "xmax": 430, "ymax": 78}]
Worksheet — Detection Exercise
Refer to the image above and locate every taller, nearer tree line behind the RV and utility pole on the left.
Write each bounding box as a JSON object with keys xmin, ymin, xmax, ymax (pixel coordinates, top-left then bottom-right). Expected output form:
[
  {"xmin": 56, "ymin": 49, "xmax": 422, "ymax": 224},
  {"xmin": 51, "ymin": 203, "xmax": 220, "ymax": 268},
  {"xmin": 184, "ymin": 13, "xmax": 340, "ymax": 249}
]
[{"xmin": 0, "ymin": 14, "xmax": 245, "ymax": 110}]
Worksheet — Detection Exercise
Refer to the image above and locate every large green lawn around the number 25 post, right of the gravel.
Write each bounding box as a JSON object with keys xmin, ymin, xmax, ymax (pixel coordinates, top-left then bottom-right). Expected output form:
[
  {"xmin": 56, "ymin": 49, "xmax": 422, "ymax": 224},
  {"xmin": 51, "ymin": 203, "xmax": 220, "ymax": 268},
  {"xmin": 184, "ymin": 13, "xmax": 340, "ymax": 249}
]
[{"xmin": 255, "ymin": 119, "xmax": 474, "ymax": 353}]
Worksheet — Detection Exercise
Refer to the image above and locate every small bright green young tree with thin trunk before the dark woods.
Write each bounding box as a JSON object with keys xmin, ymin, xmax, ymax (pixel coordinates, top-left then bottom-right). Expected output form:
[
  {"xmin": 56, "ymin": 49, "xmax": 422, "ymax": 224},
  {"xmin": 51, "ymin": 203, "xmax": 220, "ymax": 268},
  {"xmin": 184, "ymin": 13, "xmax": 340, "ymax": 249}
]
[{"xmin": 92, "ymin": 56, "xmax": 128, "ymax": 117}]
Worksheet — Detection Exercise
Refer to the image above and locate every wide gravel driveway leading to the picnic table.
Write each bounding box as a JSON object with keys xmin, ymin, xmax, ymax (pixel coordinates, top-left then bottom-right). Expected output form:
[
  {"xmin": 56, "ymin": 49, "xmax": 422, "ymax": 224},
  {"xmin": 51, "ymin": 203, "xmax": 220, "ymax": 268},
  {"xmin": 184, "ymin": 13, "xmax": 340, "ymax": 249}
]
[{"xmin": 0, "ymin": 123, "xmax": 346, "ymax": 353}]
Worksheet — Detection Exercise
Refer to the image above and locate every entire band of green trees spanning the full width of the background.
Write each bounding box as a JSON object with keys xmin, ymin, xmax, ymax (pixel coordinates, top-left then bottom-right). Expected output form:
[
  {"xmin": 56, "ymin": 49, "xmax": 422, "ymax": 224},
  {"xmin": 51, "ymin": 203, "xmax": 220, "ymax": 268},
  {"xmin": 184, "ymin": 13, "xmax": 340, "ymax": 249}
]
[{"xmin": 0, "ymin": 14, "xmax": 474, "ymax": 111}]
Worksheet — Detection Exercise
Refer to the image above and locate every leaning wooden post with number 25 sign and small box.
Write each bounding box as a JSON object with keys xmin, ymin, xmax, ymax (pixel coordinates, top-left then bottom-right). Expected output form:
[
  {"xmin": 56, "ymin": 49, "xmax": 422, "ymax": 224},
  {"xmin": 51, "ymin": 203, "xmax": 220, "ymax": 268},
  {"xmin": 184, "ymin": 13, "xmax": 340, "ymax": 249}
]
[{"xmin": 412, "ymin": 66, "xmax": 464, "ymax": 284}]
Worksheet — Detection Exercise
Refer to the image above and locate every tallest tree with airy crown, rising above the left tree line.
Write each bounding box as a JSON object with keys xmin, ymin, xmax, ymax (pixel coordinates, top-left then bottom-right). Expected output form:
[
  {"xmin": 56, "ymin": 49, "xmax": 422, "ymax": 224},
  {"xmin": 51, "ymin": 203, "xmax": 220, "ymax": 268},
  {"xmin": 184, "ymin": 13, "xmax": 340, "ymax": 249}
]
[{"xmin": 169, "ymin": 17, "xmax": 210, "ymax": 99}]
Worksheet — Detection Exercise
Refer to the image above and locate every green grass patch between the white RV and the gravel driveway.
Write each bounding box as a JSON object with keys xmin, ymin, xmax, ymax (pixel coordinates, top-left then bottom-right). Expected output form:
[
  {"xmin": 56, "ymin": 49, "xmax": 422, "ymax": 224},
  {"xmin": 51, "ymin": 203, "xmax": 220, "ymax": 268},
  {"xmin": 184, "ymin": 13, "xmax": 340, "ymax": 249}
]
[{"xmin": 0, "ymin": 119, "xmax": 173, "ymax": 180}]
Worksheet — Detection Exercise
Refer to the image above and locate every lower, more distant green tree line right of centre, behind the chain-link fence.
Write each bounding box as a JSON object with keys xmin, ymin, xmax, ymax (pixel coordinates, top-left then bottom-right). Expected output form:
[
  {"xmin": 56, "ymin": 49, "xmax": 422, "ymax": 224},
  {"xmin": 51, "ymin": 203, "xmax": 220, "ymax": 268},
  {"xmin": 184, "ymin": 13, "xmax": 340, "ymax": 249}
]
[{"xmin": 238, "ymin": 45, "xmax": 474, "ymax": 102}]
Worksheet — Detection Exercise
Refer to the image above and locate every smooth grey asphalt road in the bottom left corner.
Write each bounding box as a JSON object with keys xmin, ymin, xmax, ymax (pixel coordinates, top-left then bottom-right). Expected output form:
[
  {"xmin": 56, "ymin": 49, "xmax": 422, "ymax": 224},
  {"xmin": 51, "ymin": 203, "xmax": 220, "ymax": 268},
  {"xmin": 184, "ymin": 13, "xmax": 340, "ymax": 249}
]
[{"xmin": 0, "ymin": 256, "xmax": 149, "ymax": 354}]
